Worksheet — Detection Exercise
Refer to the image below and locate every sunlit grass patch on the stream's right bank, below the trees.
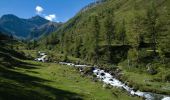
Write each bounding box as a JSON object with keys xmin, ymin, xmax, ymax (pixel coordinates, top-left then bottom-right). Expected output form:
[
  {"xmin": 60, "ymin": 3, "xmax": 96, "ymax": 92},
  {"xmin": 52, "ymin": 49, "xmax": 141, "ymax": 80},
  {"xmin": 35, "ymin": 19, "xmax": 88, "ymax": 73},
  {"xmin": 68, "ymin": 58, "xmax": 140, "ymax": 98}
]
[{"xmin": 121, "ymin": 67, "xmax": 170, "ymax": 95}]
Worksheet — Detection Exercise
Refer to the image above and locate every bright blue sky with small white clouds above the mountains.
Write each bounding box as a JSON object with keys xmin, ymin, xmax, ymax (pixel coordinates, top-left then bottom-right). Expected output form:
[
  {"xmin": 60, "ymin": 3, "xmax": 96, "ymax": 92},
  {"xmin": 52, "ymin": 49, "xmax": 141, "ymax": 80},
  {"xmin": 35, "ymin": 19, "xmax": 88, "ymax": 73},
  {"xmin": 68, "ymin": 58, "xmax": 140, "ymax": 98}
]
[{"xmin": 0, "ymin": 0, "xmax": 96, "ymax": 22}]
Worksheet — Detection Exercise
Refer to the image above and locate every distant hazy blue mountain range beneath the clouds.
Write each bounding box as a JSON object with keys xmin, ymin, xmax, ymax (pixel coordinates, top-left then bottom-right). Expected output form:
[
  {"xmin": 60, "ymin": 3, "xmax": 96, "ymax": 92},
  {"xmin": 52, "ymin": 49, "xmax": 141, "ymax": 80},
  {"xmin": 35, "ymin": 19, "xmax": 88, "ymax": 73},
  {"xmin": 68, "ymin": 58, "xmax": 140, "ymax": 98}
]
[{"xmin": 0, "ymin": 14, "xmax": 61, "ymax": 39}]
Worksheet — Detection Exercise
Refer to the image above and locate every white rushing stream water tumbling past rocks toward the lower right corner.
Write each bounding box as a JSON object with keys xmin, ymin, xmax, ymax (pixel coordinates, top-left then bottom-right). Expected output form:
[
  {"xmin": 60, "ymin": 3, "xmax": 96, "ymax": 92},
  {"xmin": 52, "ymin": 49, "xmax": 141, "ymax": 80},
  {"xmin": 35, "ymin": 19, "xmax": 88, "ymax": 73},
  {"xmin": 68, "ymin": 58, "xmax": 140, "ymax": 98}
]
[{"xmin": 57, "ymin": 62, "xmax": 170, "ymax": 100}]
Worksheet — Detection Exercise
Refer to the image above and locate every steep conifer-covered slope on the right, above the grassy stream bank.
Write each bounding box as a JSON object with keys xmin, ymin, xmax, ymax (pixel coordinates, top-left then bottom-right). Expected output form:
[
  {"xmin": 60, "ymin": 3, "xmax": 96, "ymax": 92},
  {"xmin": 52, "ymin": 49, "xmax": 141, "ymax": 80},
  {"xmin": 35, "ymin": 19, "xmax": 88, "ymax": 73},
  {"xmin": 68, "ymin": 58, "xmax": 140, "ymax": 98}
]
[{"xmin": 46, "ymin": 0, "xmax": 170, "ymax": 63}]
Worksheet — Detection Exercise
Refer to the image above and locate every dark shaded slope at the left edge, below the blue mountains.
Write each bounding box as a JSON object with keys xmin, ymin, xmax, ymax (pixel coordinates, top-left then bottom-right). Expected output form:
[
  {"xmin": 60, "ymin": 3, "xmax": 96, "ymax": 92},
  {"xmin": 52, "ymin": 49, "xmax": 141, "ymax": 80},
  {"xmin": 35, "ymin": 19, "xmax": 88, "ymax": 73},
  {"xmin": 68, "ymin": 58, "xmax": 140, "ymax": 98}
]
[{"xmin": 0, "ymin": 32, "xmax": 28, "ymax": 68}]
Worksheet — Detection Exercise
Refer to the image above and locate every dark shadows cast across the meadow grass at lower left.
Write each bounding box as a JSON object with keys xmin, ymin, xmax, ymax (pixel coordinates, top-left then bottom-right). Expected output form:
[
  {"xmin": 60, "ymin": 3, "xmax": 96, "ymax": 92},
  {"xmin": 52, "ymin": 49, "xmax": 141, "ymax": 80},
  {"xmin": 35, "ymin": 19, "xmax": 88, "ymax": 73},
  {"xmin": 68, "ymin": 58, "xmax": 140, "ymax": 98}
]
[{"xmin": 0, "ymin": 63, "xmax": 82, "ymax": 100}]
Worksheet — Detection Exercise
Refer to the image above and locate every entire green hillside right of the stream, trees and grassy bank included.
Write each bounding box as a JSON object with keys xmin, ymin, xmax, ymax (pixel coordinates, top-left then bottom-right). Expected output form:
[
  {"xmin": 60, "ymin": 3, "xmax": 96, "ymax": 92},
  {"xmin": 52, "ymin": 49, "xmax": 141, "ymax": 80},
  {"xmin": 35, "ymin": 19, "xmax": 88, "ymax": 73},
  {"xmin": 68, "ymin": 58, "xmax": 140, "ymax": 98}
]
[{"xmin": 40, "ymin": 0, "xmax": 170, "ymax": 94}]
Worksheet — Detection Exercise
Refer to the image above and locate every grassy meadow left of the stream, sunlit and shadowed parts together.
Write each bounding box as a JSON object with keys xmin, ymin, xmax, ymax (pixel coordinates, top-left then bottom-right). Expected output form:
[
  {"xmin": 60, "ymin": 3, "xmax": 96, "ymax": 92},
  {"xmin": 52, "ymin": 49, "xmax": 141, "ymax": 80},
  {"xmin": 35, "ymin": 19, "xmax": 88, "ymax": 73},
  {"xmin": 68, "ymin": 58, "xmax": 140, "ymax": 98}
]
[{"xmin": 0, "ymin": 61, "xmax": 139, "ymax": 100}]
